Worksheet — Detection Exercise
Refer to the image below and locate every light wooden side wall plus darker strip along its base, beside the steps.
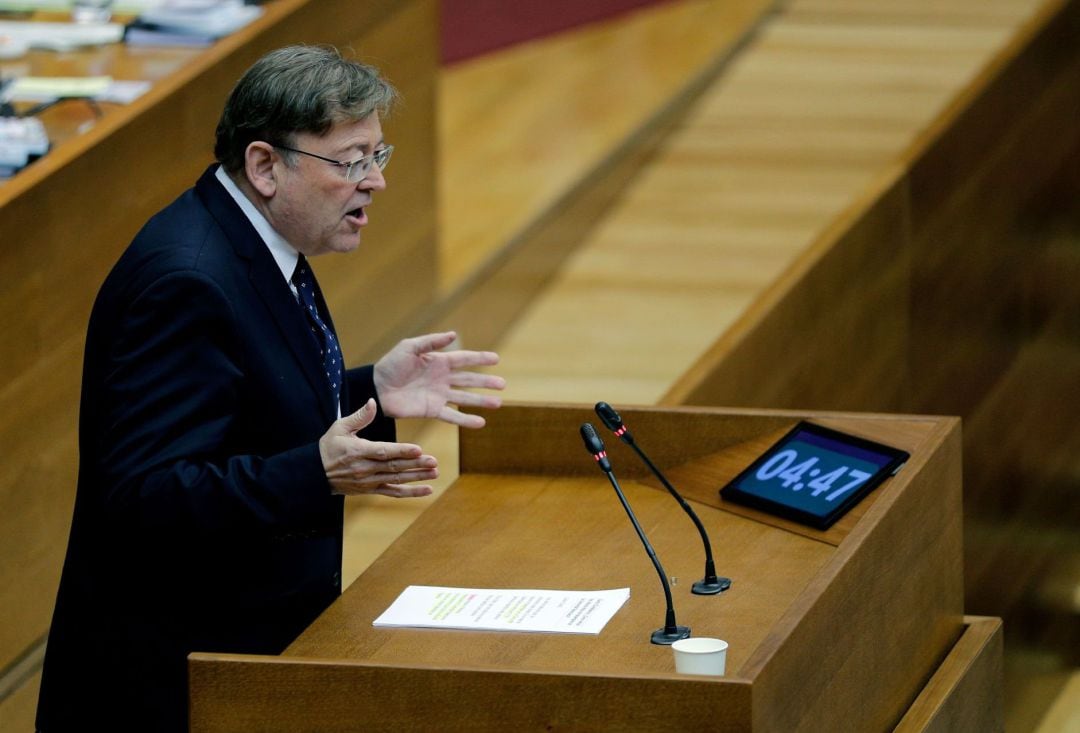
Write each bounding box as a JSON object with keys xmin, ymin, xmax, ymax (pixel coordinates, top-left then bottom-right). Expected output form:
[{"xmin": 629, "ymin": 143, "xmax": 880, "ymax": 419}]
[{"xmin": 410, "ymin": 0, "xmax": 774, "ymax": 348}]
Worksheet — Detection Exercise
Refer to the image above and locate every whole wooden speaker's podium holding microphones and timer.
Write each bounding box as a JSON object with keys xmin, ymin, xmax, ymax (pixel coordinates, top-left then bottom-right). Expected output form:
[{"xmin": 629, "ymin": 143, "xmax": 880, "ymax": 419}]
[{"xmin": 190, "ymin": 405, "xmax": 1002, "ymax": 732}]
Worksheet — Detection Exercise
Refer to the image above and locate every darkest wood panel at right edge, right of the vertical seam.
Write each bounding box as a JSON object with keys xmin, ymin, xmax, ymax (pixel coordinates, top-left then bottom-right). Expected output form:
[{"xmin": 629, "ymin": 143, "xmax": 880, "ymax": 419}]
[{"xmin": 910, "ymin": 2, "xmax": 1080, "ymax": 647}]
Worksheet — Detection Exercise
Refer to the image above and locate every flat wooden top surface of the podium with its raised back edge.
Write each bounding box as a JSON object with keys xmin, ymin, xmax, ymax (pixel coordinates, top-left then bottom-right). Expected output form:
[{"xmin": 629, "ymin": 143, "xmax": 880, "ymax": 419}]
[{"xmin": 285, "ymin": 405, "xmax": 961, "ymax": 681}]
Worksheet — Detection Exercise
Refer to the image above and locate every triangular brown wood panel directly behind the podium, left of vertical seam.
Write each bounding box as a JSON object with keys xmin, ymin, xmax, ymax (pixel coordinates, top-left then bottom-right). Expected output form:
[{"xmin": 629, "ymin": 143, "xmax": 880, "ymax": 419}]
[{"xmin": 661, "ymin": 173, "xmax": 910, "ymax": 411}]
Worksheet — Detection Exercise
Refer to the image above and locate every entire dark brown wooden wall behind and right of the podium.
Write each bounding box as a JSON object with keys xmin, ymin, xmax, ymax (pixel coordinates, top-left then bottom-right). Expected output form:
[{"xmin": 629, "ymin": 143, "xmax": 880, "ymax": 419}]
[{"xmin": 662, "ymin": 2, "xmax": 1080, "ymax": 665}]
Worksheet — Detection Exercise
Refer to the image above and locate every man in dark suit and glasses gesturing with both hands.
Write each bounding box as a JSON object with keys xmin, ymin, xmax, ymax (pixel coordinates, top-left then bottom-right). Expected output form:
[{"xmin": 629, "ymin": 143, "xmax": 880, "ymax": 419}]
[{"xmin": 38, "ymin": 46, "xmax": 503, "ymax": 732}]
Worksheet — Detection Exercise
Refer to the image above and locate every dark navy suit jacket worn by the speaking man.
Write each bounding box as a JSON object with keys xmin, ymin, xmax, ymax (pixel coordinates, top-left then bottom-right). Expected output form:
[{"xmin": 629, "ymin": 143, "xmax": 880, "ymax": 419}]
[{"xmin": 38, "ymin": 168, "xmax": 394, "ymax": 731}]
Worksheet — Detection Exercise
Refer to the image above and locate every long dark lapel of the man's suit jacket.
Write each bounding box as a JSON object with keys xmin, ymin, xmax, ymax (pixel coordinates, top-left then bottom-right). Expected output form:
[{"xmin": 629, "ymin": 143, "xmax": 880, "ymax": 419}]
[{"xmin": 195, "ymin": 166, "xmax": 337, "ymax": 424}]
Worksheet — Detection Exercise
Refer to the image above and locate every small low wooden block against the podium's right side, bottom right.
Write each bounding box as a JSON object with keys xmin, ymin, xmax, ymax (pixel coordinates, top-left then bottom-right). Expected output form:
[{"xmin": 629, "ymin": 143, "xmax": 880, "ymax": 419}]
[{"xmin": 895, "ymin": 616, "xmax": 1004, "ymax": 733}]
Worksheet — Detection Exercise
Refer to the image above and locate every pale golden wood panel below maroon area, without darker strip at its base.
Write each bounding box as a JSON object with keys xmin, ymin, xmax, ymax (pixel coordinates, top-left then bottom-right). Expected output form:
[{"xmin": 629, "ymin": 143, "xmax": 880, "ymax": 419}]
[{"xmin": 429, "ymin": 0, "xmax": 777, "ymax": 290}]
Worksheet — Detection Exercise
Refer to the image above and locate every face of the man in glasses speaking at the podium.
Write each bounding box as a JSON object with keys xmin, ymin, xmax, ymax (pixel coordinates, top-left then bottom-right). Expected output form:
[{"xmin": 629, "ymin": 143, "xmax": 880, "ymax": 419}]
[{"xmin": 267, "ymin": 114, "xmax": 387, "ymax": 257}]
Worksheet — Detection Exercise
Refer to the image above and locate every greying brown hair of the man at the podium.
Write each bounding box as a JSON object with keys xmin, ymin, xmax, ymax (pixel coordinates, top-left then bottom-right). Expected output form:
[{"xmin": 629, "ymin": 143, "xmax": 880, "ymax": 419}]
[{"xmin": 214, "ymin": 45, "xmax": 397, "ymax": 173}]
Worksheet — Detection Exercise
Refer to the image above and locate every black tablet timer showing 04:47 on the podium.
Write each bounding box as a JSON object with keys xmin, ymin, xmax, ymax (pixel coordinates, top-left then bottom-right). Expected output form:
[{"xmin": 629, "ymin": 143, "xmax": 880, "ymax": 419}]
[{"xmin": 720, "ymin": 422, "xmax": 908, "ymax": 529}]
